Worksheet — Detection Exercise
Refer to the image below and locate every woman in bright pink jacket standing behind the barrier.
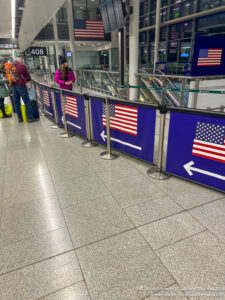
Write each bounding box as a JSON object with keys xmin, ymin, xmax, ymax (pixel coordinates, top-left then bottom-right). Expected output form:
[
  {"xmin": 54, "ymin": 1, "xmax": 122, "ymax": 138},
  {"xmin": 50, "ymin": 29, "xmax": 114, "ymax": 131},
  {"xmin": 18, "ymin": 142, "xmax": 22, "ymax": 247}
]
[{"xmin": 55, "ymin": 58, "xmax": 75, "ymax": 90}]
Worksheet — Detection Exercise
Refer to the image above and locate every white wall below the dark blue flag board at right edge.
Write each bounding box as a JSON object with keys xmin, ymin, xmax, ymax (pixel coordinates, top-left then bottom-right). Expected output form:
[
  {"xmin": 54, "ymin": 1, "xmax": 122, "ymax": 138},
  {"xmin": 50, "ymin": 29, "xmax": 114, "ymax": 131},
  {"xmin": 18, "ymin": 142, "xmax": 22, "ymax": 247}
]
[{"xmin": 188, "ymin": 79, "xmax": 225, "ymax": 109}]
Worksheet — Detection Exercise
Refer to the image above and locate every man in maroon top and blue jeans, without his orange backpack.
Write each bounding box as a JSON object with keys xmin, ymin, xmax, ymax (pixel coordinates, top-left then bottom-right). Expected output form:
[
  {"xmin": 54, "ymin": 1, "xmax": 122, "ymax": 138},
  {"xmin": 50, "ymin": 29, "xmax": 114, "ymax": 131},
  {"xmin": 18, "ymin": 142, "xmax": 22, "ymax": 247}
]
[{"xmin": 12, "ymin": 58, "xmax": 37, "ymax": 123}]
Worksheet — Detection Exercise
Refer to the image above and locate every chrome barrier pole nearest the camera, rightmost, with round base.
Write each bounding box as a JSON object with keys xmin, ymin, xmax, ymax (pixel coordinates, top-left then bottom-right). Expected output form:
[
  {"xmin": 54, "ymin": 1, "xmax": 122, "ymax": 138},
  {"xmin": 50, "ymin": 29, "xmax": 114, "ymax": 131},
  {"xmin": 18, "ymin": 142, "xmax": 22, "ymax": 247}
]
[{"xmin": 147, "ymin": 106, "xmax": 170, "ymax": 180}]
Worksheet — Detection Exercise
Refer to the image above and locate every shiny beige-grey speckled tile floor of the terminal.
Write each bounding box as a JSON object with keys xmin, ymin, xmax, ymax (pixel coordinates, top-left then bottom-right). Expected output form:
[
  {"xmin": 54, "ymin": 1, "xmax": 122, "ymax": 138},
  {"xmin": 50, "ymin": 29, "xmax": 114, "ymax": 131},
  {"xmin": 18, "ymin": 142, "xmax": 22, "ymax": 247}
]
[{"xmin": 0, "ymin": 117, "xmax": 225, "ymax": 300}]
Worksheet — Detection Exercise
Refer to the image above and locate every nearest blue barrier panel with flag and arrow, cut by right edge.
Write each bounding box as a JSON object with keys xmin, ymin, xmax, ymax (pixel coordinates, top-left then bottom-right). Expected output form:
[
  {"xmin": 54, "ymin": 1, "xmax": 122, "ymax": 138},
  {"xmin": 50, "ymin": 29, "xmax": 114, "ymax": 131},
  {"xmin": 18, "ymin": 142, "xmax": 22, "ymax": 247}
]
[{"xmin": 166, "ymin": 112, "xmax": 225, "ymax": 192}]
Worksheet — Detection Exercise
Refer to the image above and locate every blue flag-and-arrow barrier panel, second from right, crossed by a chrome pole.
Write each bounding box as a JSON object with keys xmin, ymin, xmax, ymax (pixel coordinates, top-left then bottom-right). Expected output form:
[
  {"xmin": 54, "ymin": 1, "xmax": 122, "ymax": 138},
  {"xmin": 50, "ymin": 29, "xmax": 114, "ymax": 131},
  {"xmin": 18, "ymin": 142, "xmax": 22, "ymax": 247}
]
[{"xmin": 91, "ymin": 98, "xmax": 156, "ymax": 163}]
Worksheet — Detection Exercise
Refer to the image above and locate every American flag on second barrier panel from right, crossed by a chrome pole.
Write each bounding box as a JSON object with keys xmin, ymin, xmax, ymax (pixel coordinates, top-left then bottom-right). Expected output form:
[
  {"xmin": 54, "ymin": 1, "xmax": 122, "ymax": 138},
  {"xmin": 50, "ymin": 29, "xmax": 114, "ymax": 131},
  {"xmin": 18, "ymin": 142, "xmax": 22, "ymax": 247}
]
[{"xmin": 102, "ymin": 104, "xmax": 138, "ymax": 135}]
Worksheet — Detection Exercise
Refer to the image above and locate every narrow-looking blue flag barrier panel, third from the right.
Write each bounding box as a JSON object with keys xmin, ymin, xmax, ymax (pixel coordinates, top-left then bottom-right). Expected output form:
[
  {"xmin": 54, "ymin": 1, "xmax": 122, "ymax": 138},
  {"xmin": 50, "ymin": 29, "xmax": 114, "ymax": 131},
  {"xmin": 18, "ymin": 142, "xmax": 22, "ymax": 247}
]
[{"xmin": 63, "ymin": 92, "xmax": 87, "ymax": 138}]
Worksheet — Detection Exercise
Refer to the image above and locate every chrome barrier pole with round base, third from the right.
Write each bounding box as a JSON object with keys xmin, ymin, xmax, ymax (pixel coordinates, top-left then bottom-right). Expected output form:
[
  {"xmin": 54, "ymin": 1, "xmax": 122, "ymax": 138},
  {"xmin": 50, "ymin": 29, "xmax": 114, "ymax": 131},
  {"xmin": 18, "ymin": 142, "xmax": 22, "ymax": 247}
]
[{"xmin": 81, "ymin": 95, "xmax": 98, "ymax": 148}]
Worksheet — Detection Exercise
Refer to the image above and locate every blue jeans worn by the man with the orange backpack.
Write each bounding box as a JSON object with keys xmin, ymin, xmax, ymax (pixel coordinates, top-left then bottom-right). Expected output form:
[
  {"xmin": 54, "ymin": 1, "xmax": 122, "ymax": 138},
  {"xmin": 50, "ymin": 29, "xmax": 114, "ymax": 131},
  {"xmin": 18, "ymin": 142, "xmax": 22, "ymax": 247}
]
[{"xmin": 13, "ymin": 84, "xmax": 34, "ymax": 120}]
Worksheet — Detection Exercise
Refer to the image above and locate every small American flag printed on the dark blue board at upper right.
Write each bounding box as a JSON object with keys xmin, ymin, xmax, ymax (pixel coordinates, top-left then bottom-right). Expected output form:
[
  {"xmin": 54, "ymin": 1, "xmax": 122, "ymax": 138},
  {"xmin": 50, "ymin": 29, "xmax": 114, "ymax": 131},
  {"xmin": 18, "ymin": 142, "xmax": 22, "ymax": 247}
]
[{"xmin": 197, "ymin": 48, "xmax": 223, "ymax": 67}]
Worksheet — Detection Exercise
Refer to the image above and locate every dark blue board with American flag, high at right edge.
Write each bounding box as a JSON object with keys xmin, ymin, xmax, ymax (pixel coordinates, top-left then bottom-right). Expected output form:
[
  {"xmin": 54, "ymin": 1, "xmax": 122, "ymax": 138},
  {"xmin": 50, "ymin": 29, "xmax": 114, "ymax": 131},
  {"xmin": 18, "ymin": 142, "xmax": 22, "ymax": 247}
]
[{"xmin": 191, "ymin": 36, "xmax": 225, "ymax": 76}]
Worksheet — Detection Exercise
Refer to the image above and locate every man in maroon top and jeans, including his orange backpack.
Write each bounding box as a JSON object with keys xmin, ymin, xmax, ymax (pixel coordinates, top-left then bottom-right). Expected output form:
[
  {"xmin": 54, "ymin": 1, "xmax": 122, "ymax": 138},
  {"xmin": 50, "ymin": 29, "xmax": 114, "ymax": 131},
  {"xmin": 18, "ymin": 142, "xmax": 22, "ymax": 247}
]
[{"xmin": 5, "ymin": 58, "xmax": 36, "ymax": 123}]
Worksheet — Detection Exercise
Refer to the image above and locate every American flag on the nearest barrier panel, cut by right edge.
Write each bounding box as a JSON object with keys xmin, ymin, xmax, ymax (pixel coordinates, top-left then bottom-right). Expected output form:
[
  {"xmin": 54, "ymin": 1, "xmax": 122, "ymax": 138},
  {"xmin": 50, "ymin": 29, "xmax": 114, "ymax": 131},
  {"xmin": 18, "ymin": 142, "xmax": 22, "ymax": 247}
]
[{"xmin": 192, "ymin": 122, "xmax": 225, "ymax": 163}]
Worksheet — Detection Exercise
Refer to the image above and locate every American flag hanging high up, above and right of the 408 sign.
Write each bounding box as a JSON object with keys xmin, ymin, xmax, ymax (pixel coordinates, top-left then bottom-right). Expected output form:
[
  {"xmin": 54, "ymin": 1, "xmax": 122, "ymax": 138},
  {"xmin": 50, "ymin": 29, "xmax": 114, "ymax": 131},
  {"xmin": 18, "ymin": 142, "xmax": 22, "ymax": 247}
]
[{"xmin": 74, "ymin": 19, "xmax": 105, "ymax": 39}]
